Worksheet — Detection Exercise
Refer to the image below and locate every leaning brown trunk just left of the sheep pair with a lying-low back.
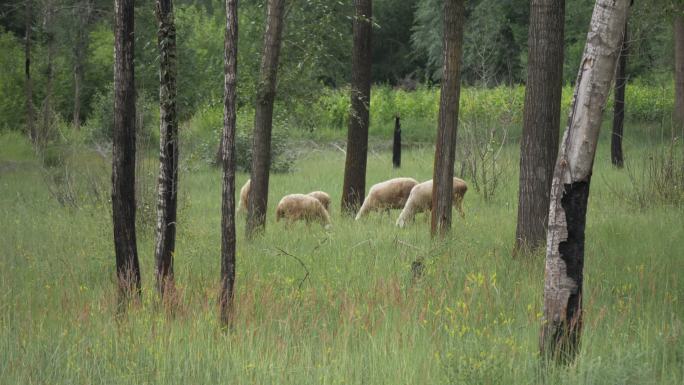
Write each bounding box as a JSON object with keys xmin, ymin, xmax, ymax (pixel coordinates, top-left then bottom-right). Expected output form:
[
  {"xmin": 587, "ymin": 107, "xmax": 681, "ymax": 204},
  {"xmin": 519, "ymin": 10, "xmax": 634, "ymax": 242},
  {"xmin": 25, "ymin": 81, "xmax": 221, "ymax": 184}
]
[{"xmin": 246, "ymin": 0, "xmax": 285, "ymax": 238}]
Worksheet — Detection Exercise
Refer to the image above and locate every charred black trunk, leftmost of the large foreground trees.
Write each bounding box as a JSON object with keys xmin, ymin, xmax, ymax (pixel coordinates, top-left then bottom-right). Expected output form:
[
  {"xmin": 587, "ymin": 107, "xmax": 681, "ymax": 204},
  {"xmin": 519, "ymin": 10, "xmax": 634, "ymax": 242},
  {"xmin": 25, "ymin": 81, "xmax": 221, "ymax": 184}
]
[{"xmin": 112, "ymin": 0, "xmax": 140, "ymax": 304}]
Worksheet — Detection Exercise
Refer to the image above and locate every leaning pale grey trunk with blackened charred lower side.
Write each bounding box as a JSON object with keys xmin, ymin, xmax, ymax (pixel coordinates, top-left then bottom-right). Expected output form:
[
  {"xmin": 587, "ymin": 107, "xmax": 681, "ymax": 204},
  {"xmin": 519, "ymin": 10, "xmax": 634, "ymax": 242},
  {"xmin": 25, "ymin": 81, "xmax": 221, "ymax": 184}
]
[{"xmin": 540, "ymin": 0, "xmax": 629, "ymax": 361}]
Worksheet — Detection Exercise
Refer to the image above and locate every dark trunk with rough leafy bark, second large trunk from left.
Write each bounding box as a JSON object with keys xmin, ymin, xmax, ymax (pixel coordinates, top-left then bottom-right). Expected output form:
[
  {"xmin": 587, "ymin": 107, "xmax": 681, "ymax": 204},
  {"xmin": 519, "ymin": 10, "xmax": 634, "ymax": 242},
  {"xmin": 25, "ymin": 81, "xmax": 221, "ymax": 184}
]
[{"xmin": 154, "ymin": 0, "xmax": 178, "ymax": 297}]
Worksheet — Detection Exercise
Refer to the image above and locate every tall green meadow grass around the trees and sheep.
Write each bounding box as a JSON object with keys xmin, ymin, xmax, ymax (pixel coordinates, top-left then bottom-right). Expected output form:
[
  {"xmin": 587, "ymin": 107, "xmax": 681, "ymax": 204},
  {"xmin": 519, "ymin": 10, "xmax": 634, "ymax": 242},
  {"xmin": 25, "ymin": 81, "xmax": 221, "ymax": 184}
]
[{"xmin": 0, "ymin": 127, "xmax": 684, "ymax": 384}]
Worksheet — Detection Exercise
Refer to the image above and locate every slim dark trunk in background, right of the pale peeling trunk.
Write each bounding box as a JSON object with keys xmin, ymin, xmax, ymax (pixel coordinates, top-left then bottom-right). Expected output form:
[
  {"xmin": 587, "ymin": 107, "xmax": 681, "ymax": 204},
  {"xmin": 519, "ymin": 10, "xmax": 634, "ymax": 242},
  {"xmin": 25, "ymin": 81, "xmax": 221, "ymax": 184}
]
[{"xmin": 610, "ymin": 23, "xmax": 629, "ymax": 168}]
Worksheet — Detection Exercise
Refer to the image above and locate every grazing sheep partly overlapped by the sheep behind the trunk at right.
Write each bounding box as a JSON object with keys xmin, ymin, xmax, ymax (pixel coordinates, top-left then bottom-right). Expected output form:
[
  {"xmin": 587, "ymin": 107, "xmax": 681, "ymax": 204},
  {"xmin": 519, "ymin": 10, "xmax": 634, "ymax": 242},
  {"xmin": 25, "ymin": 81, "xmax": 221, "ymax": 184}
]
[{"xmin": 356, "ymin": 178, "xmax": 418, "ymax": 221}]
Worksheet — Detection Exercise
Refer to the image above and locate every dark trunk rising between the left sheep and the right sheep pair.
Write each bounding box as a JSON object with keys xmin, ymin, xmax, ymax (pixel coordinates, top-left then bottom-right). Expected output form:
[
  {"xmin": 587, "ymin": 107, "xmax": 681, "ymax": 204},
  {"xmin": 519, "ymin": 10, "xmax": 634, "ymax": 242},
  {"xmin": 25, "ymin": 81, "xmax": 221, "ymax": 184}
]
[{"xmin": 342, "ymin": 0, "xmax": 373, "ymax": 215}]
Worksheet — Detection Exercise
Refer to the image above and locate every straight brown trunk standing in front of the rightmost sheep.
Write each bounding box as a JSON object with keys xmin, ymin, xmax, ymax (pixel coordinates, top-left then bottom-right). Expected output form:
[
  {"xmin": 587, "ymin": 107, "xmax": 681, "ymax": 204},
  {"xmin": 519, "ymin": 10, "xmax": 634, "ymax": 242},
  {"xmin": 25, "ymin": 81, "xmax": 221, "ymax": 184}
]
[{"xmin": 430, "ymin": 0, "xmax": 465, "ymax": 236}]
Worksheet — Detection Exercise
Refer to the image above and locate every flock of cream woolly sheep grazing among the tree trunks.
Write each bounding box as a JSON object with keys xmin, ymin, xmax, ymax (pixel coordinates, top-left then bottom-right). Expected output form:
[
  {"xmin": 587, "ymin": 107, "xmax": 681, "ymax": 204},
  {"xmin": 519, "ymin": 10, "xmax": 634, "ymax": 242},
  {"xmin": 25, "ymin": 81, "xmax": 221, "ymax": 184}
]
[{"xmin": 238, "ymin": 178, "xmax": 468, "ymax": 228}]
